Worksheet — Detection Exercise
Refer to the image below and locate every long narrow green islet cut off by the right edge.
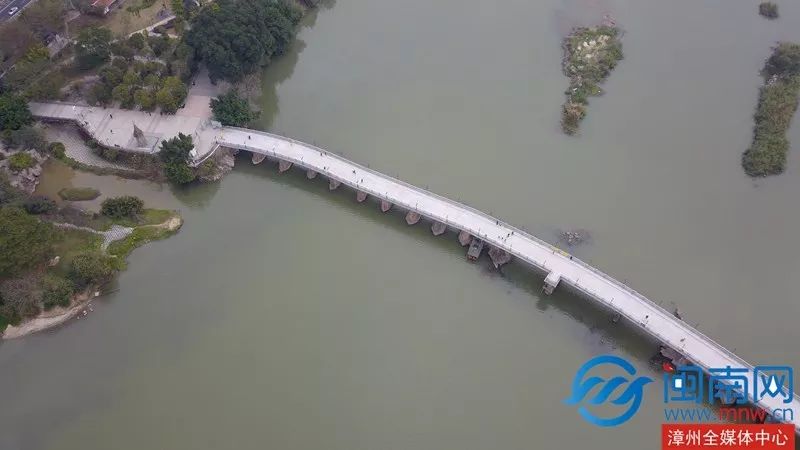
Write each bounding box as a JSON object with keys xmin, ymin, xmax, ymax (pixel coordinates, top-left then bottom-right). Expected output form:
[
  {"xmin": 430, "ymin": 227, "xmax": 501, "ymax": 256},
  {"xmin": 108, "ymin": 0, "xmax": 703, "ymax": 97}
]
[{"xmin": 742, "ymin": 42, "xmax": 800, "ymax": 177}]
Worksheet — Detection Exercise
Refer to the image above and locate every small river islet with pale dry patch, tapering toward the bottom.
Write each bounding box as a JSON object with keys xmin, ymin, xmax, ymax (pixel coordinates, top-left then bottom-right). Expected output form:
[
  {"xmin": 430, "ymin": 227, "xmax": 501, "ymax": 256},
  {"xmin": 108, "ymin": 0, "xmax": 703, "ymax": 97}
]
[{"xmin": 561, "ymin": 25, "xmax": 623, "ymax": 135}]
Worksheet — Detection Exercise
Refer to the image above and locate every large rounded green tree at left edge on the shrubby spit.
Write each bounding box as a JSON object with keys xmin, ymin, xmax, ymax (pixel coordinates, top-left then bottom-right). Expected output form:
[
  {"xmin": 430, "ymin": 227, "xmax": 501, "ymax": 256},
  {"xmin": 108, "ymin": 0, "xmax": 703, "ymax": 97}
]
[{"xmin": 0, "ymin": 207, "xmax": 53, "ymax": 277}]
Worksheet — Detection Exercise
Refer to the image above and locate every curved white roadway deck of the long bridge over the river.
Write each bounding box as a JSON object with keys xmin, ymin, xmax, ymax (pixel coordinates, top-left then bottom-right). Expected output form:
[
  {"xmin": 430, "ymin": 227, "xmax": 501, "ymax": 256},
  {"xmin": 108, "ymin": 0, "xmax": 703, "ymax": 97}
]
[{"xmin": 217, "ymin": 127, "xmax": 800, "ymax": 430}]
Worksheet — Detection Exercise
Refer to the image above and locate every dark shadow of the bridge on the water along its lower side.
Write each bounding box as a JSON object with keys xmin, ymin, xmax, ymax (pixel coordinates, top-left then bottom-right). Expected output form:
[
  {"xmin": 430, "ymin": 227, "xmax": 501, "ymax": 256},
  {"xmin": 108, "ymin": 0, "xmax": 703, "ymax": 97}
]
[{"xmin": 234, "ymin": 155, "xmax": 658, "ymax": 370}]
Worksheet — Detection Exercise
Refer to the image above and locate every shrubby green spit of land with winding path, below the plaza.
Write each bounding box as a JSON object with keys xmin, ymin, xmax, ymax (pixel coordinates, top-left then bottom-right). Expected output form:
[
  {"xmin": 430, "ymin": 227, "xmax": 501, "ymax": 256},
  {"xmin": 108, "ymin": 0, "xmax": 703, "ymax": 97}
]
[{"xmin": 0, "ymin": 177, "xmax": 181, "ymax": 333}]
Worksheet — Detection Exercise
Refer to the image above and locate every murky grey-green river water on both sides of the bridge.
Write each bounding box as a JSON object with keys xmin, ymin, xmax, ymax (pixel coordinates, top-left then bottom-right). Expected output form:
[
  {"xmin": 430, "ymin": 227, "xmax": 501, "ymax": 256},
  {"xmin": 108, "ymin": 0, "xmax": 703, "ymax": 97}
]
[{"xmin": 0, "ymin": 0, "xmax": 800, "ymax": 450}]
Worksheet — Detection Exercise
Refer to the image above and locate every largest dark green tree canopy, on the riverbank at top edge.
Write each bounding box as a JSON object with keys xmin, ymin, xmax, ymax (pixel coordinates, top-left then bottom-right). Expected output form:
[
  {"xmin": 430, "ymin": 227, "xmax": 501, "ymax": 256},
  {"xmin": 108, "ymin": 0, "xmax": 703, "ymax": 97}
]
[{"xmin": 186, "ymin": 0, "xmax": 302, "ymax": 81}]
